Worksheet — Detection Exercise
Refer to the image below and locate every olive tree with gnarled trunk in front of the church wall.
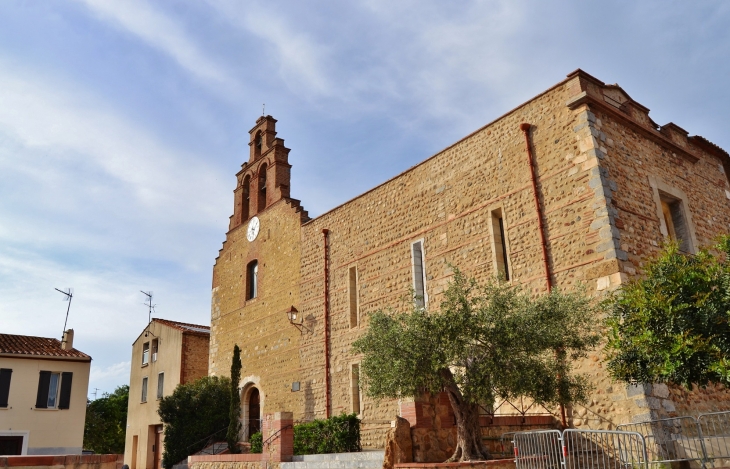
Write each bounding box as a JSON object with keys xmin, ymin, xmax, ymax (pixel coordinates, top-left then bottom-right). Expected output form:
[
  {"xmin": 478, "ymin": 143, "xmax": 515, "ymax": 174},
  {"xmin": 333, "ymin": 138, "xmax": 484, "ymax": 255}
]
[{"xmin": 353, "ymin": 269, "xmax": 600, "ymax": 461}]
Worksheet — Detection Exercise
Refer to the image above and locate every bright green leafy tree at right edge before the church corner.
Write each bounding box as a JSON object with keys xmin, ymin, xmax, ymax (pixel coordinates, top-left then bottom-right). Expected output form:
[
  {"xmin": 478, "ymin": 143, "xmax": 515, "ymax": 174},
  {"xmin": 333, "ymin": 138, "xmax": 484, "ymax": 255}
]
[{"xmin": 606, "ymin": 236, "xmax": 730, "ymax": 388}]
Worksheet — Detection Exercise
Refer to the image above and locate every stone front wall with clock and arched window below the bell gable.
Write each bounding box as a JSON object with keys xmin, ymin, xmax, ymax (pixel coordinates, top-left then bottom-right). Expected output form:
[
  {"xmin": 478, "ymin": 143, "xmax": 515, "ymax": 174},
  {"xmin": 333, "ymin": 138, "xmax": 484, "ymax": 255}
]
[{"xmin": 210, "ymin": 200, "xmax": 304, "ymax": 425}]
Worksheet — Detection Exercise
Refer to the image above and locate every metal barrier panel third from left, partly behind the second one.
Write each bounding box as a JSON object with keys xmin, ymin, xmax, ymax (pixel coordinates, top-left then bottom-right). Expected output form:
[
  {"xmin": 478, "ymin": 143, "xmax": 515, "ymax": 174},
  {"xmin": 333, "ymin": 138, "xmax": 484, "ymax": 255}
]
[{"xmin": 616, "ymin": 417, "xmax": 707, "ymax": 468}]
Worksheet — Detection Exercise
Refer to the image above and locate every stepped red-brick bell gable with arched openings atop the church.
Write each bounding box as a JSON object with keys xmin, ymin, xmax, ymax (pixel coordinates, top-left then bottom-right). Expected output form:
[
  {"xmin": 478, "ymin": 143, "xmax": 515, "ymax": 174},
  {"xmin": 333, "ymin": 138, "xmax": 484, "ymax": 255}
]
[{"xmin": 229, "ymin": 116, "xmax": 291, "ymax": 229}]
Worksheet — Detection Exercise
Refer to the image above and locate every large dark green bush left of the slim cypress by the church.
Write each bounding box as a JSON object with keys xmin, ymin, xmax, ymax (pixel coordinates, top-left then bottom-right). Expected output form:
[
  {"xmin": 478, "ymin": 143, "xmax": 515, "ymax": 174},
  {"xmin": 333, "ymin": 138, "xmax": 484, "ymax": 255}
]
[{"xmin": 157, "ymin": 376, "xmax": 231, "ymax": 469}]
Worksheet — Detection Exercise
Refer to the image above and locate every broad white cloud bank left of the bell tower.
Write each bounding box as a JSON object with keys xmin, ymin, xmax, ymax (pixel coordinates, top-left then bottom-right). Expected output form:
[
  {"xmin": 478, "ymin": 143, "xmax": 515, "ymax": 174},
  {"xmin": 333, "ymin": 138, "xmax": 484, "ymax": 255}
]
[{"xmin": 0, "ymin": 60, "xmax": 230, "ymax": 263}]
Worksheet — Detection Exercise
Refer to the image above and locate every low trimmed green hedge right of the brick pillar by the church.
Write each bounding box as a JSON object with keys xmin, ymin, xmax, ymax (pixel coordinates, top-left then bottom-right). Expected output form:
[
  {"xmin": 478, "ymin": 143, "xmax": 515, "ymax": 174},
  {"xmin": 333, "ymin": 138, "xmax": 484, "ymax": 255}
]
[{"xmin": 290, "ymin": 414, "xmax": 361, "ymax": 454}]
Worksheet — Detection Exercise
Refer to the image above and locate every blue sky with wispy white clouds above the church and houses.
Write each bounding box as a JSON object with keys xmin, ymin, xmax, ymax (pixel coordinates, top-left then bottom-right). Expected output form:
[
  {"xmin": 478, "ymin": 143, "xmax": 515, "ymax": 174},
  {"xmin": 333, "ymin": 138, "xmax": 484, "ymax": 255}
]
[{"xmin": 0, "ymin": 0, "xmax": 730, "ymax": 398}]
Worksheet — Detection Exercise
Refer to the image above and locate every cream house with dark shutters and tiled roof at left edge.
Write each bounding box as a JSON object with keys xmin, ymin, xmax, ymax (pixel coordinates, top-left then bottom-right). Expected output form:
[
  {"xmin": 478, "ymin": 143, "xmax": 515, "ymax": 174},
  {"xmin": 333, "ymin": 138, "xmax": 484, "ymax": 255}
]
[{"xmin": 0, "ymin": 329, "xmax": 91, "ymax": 455}]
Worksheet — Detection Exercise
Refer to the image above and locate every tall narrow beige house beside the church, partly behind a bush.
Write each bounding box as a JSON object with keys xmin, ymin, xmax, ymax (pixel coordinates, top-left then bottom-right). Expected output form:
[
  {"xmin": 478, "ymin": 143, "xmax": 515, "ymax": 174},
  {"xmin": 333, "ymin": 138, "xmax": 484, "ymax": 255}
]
[{"xmin": 124, "ymin": 318, "xmax": 210, "ymax": 469}]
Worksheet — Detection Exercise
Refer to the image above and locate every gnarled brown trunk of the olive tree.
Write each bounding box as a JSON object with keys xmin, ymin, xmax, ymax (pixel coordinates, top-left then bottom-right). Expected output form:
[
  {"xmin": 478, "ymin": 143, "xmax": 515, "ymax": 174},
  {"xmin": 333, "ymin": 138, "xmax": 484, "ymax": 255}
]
[{"xmin": 441, "ymin": 369, "xmax": 492, "ymax": 462}]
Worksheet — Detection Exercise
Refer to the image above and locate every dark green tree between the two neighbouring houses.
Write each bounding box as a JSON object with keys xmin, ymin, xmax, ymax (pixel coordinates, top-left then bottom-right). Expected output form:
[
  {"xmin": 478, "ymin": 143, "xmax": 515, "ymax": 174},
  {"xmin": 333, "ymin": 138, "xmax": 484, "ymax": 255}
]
[{"xmin": 84, "ymin": 384, "xmax": 129, "ymax": 454}]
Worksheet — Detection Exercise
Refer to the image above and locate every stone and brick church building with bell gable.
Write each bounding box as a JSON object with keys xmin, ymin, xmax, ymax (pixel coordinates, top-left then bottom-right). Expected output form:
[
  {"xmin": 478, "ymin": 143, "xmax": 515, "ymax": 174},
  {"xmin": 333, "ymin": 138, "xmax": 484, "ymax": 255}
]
[{"xmin": 209, "ymin": 70, "xmax": 730, "ymax": 447}]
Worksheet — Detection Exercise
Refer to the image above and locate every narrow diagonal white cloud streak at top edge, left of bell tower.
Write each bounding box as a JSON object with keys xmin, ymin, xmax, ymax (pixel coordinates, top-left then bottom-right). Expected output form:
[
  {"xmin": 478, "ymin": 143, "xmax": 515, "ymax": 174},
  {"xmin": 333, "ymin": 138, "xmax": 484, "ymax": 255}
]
[{"xmin": 73, "ymin": 0, "xmax": 237, "ymax": 92}]
